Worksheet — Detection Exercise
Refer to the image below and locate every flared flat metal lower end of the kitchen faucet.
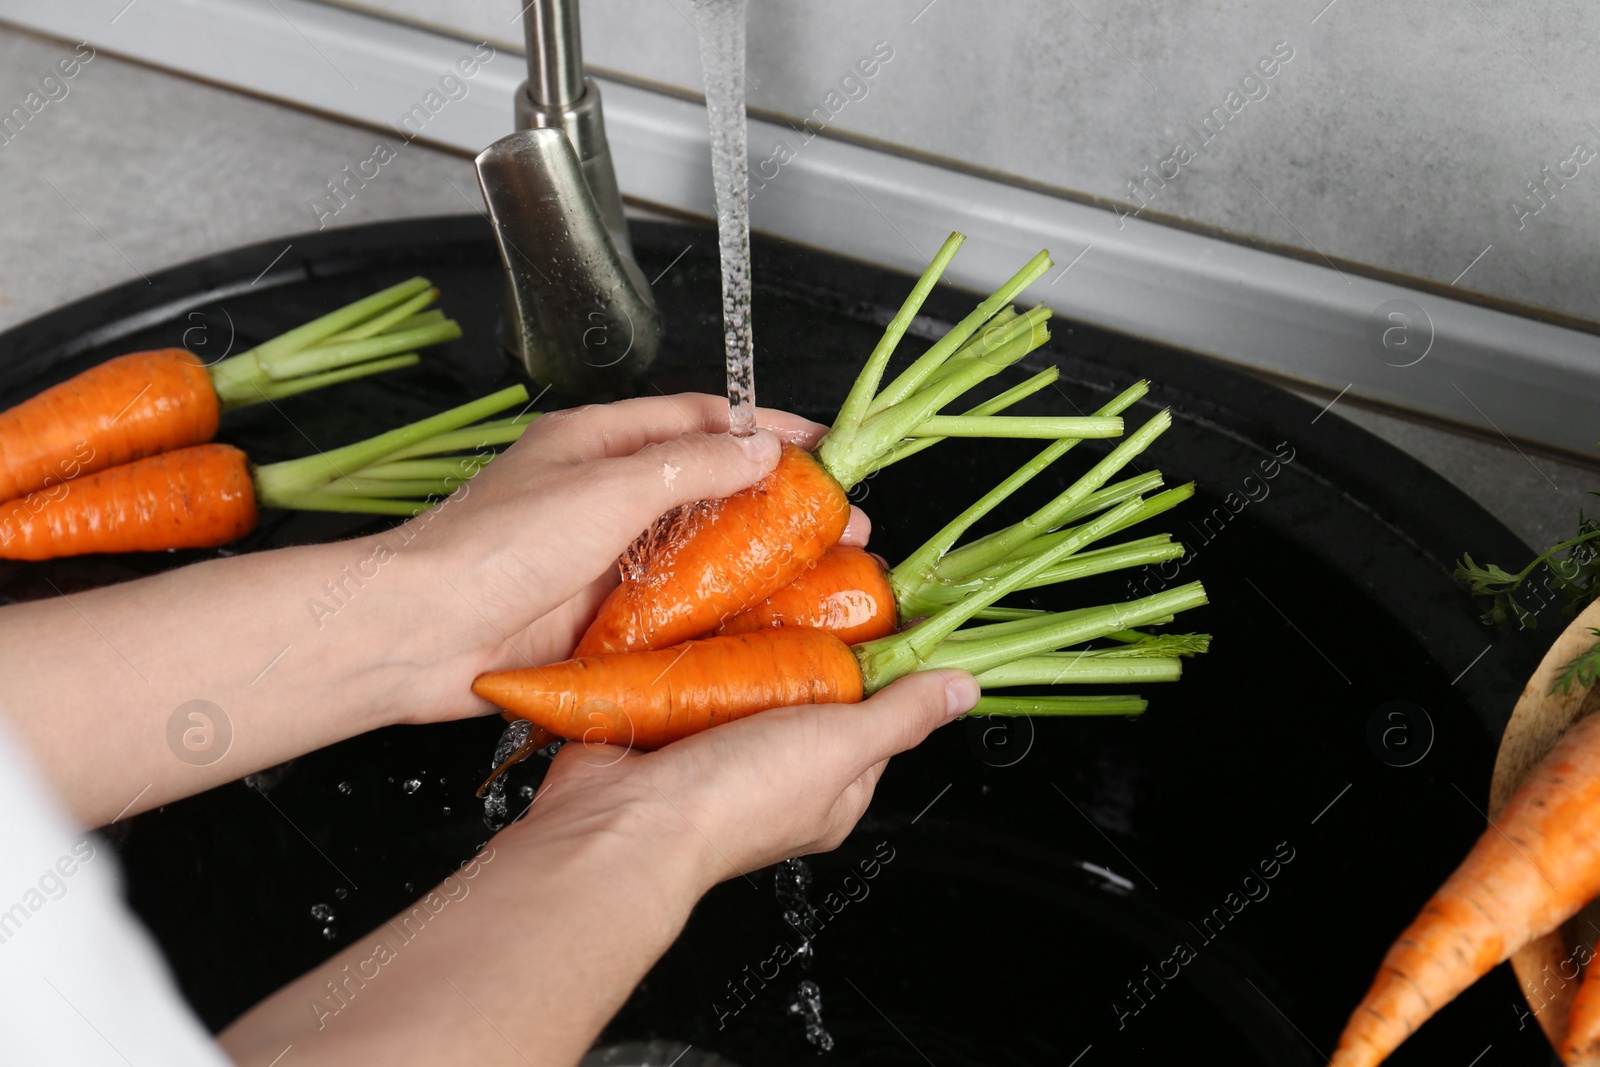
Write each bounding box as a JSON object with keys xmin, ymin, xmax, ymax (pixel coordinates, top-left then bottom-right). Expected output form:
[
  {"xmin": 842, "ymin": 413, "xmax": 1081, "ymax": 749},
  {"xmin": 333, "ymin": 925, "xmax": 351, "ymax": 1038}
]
[{"xmin": 477, "ymin": 126, "xmax": 661, "ymax": 397}]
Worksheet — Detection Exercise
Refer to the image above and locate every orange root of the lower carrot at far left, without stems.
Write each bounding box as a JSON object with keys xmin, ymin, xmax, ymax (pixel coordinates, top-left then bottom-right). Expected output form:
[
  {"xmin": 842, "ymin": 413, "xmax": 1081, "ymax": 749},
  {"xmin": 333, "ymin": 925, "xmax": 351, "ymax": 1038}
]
[{"xmin": 0, "ymin": 445, "xmax": 258, "ymax": 560}]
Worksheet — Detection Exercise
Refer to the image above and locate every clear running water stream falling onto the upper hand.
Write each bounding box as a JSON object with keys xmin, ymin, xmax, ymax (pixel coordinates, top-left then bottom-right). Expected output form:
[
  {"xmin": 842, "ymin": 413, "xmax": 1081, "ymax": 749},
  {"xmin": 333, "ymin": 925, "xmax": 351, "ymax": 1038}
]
[{"xmin": 694, "ymin": 0, "xmax": 755, "ymax": 437}]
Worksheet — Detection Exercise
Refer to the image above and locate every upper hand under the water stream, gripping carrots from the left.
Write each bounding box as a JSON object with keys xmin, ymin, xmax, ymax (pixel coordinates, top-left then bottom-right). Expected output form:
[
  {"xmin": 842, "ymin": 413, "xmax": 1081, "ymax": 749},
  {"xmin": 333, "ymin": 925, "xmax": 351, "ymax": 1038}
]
[{"xmin": 373, "ymin": 394, "xmax": 869, "ymax": 721}]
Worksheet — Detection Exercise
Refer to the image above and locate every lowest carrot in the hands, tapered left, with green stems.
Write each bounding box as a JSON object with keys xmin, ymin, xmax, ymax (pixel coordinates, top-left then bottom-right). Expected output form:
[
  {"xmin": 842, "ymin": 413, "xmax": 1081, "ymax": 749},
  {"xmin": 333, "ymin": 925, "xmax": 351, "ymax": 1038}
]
[{"xmin": 472, "ymin": 476, "xmax": 1205, "ymax": 747}]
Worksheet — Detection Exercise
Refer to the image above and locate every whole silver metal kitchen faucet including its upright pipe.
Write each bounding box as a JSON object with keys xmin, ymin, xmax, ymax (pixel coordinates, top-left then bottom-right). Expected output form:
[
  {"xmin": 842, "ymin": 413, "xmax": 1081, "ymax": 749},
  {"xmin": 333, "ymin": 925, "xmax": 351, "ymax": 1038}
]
[{"xmin": 477, "ymin": 0, "xmax": 661, "ymax": 398}]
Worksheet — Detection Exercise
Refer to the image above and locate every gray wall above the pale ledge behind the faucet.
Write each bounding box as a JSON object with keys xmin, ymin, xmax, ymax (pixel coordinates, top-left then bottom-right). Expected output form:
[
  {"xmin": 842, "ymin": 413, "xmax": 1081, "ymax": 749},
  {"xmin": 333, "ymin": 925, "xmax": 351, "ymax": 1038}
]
[{"xmin": 331, "ymin": 0, "xmax": 1600, "ymax": 323}]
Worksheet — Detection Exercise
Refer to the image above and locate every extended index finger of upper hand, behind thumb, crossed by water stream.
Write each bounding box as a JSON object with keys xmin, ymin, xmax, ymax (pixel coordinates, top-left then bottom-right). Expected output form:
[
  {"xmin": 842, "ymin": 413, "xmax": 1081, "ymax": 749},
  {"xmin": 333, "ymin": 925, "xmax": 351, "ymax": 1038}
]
[{"xmin": 523, "ymin": 394, "xmax": 827, "ymax": 462}]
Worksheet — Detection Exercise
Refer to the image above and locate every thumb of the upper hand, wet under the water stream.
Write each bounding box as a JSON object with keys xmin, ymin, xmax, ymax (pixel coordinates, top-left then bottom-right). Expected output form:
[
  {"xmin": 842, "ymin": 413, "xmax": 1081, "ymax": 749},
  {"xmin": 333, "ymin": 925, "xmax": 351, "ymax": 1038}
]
[{"xmin": 603, "ymin": 430, "xmax": 782, "ymax": 530}]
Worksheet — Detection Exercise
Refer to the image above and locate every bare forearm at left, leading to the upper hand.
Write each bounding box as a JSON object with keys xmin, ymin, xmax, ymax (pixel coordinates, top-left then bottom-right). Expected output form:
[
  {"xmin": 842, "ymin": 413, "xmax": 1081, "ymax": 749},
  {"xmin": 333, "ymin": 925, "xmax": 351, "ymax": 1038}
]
[{"xmin": 0, "ymin": 531, "xmax": 470, "ymax": 825}]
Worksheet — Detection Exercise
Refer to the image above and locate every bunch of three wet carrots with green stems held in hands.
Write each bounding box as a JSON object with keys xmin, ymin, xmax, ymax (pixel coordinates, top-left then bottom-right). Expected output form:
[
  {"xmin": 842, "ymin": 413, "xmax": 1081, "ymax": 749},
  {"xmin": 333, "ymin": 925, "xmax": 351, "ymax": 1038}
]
[{"xmin": 472, "ymin": 234, "xmax": 1210, "ymax": 771}]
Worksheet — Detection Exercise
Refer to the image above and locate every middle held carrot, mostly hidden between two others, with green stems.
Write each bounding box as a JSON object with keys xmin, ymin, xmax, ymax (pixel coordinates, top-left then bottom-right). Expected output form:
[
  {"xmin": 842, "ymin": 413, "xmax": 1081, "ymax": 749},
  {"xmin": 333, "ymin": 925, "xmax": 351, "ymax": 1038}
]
[{"xmin": 717, "ymin": 382, "xmax": 1194, "ymax": 643}]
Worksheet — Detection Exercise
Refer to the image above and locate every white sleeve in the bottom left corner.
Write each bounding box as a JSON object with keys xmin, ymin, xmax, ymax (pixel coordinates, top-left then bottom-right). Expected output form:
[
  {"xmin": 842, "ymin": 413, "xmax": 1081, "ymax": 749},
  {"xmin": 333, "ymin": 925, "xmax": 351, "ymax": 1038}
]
[{"xmin": 0, "ymin": 721, "xmax": 230, "ymax": 1067}]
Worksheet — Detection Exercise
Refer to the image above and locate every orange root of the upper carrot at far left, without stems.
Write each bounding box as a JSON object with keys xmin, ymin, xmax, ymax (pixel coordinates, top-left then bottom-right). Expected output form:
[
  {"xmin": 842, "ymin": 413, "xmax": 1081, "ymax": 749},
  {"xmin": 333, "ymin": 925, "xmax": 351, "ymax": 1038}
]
[{"xmin": 0, "ymin": 349, "xmax": 219, "ymax": 501}]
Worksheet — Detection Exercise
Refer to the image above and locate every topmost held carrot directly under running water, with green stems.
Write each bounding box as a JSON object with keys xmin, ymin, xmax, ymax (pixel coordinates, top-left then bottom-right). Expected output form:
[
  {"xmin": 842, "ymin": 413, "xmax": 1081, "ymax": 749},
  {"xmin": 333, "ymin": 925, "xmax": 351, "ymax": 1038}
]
[{"xmin": 578, "ymin": 234, "xmax": 1122, "ymax": 656}]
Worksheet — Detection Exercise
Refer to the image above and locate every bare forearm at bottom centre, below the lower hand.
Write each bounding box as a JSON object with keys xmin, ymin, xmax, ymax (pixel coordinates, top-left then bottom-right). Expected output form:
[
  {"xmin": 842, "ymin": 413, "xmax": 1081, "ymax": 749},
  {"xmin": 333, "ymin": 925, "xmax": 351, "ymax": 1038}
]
[{"xmin": 221, "ymin": 811, "xmax": 707, "ymax": 1067}]
